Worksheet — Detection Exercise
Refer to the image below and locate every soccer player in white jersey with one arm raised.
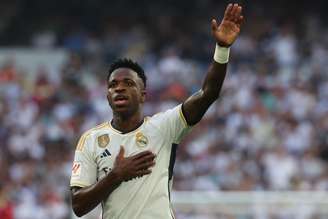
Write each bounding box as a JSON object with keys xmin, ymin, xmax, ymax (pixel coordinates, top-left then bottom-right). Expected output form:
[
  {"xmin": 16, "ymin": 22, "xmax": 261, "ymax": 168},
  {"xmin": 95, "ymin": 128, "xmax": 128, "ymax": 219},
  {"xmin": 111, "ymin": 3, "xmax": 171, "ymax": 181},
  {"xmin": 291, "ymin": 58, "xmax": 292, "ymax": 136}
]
[{"xmin": 70, "ymin": 4, "xmax": 243, "ymax": 219}]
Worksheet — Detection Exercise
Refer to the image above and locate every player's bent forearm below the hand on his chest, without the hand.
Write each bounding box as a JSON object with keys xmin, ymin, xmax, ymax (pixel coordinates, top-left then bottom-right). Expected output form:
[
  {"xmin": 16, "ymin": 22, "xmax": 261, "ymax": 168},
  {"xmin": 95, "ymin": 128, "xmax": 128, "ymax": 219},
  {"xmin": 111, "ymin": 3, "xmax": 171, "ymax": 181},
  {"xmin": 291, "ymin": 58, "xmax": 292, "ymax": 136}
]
[{"xmin": 72, "ymin": 171, "xmax": 121, "ymax": 217}]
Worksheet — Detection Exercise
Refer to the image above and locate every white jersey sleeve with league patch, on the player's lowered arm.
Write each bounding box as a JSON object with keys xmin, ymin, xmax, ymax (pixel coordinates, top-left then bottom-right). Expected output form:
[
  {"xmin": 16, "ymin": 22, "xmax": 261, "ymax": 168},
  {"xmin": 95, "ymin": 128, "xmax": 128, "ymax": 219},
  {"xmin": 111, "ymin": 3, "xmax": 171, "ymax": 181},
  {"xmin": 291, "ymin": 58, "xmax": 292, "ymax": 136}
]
[{"xmin": 70, "ymin": 134, "xmax": 97, "ymax": 187}]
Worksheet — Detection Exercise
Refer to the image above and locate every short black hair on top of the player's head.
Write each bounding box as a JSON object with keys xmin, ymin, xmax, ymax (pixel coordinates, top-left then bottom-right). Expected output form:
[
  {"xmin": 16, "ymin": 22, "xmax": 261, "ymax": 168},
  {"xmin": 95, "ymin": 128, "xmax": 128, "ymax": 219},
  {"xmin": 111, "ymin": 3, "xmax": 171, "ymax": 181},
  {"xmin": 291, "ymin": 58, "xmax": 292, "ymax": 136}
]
[{"xmin": 107, "ymin": 58, "xmax": 147, "ymax": 87}]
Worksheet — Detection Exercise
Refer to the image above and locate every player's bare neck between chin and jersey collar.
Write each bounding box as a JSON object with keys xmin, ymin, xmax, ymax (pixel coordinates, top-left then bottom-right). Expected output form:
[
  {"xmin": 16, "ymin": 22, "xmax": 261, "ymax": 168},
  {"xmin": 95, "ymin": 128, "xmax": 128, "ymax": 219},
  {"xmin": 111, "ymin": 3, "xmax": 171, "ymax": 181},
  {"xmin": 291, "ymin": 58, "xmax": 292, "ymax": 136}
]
[{"xmin": 111, "ymin": 111, "xmax": 143, "ymax": 134}]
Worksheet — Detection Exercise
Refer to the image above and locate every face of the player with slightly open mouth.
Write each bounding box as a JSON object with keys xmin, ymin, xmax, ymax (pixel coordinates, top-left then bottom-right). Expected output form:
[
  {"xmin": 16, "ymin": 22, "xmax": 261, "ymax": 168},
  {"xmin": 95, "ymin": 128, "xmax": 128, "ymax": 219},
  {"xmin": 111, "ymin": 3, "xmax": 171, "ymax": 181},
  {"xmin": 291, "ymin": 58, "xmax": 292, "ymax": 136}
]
[{"xmin": 107, "ymin": 68, "xmax": 146, "ymax": 116}]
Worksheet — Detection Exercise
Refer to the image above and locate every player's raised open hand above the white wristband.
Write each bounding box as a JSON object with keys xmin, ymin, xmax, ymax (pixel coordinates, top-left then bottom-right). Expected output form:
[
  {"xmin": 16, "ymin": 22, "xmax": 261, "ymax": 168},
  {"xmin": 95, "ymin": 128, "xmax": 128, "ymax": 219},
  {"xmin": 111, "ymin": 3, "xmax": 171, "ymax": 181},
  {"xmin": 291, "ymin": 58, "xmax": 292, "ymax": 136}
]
[{"xmin": 211, "ymin": 4, "xmax": 244, "ymax": 47}]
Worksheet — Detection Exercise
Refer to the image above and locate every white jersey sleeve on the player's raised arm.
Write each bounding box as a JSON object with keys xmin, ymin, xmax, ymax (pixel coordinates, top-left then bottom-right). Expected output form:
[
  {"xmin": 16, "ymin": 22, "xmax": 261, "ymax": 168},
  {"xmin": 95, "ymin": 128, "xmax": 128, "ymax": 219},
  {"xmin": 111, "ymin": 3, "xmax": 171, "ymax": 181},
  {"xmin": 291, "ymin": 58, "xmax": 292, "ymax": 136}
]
[{"xmin": 155, "ymin": 104, "xmax": 192, "ymax": 144}]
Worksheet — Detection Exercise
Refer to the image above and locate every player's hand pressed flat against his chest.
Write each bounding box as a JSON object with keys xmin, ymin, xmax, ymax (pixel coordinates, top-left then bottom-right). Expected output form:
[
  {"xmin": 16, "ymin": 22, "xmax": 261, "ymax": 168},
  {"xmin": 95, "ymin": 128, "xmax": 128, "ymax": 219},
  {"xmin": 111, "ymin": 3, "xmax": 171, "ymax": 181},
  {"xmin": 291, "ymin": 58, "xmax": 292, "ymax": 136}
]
[{"xmin": 113, "ymin": 146, "xmax": 156, "ymax": 181}]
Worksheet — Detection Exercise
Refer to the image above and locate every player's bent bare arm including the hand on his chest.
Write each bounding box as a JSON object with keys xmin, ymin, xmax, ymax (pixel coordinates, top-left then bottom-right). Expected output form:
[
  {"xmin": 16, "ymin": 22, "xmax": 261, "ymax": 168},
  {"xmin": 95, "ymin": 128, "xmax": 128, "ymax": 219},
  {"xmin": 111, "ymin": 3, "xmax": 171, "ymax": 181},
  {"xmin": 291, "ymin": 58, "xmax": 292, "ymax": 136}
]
[{"xmin": 71, "ymin": 147, "xmax": 155, "ymax": 217}]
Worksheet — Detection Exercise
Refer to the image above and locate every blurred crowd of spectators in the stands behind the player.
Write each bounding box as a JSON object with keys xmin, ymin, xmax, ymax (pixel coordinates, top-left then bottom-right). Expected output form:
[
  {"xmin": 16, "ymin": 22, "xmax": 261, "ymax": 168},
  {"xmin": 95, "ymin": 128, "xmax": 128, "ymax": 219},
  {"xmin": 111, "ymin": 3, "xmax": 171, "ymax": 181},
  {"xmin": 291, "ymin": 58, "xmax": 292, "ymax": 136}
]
[{"xmin": 0, "ymin": 1, "xmax": 328, "ymax": 219}]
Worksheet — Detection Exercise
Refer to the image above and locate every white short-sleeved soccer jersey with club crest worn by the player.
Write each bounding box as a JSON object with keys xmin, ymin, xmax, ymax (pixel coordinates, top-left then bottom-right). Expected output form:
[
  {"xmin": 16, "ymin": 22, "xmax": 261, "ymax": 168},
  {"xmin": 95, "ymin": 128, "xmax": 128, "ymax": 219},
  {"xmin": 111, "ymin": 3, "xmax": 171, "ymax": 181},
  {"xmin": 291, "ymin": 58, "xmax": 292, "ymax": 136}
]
[{"xmin": 70, "ymin": 105, "xmax": 190, "ymax": 219}]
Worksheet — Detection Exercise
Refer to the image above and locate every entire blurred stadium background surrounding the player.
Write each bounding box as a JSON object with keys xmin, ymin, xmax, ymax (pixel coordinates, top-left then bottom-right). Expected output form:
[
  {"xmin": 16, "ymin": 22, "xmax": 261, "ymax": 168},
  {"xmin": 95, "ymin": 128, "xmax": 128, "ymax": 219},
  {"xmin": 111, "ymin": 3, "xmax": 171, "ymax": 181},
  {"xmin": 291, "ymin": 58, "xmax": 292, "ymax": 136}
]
[{"xmin": 0, "ymin": 0, "xmax": 328, "ymax": 219}]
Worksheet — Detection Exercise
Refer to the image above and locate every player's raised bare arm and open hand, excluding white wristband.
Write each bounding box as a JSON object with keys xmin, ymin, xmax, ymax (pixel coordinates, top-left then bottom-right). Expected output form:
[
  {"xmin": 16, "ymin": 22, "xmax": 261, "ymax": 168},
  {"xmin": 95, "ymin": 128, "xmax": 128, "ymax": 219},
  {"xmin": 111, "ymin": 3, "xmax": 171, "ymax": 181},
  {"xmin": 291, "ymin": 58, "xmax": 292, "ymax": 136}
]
[{"xmin": 182, "ymin": 4, "xmax": 243, "ymax": 125}]
